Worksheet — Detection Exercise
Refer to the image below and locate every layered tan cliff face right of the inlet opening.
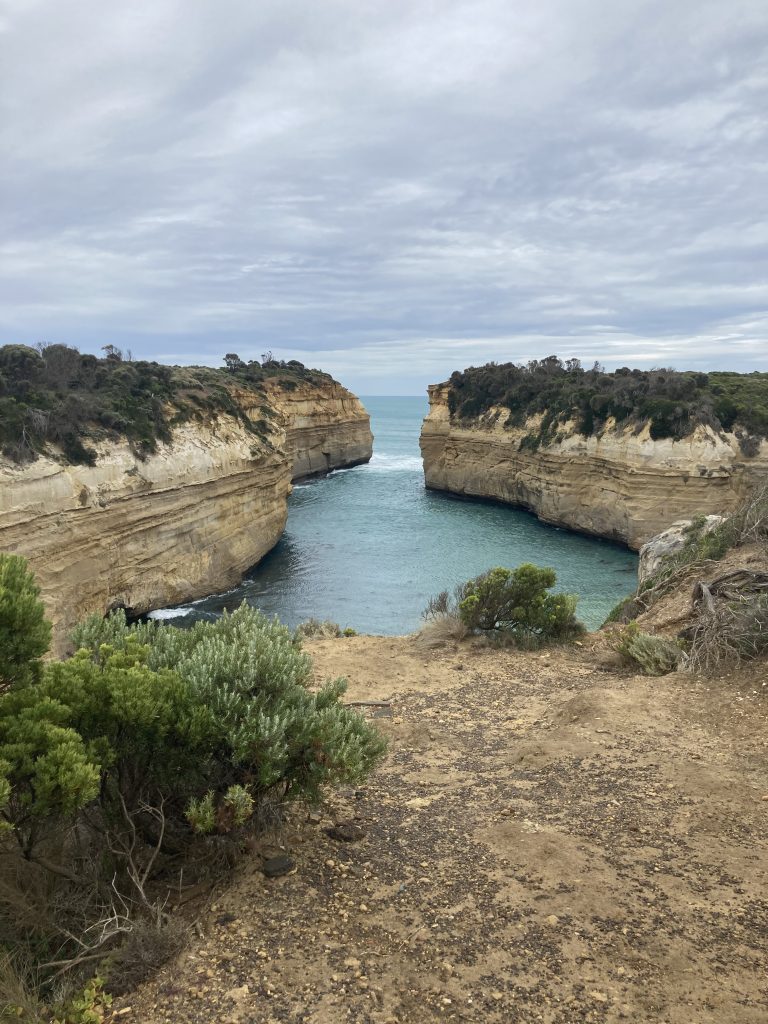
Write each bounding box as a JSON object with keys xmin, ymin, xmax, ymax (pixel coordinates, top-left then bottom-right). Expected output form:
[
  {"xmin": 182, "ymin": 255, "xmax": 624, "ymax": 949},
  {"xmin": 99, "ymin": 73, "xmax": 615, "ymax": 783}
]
[{"xmin": 421, "ymin": 384, "xmax": 768, "ymax": 548}]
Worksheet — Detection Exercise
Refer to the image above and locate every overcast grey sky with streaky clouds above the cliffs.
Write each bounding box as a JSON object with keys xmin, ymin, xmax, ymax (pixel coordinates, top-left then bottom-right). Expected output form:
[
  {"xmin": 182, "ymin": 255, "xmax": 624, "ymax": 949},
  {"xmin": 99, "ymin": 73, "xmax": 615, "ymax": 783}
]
[{"xmin": 0, "ymin": 0, "xmax": 768, "ymax": 394}]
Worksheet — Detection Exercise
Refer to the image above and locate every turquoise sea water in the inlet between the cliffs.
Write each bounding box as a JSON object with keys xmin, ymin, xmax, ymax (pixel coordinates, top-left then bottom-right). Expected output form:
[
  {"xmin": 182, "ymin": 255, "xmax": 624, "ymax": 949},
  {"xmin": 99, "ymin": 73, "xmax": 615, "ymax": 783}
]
[{"xmin": 155, "ymin": 397, "xmax": 637, "ymax": 634}]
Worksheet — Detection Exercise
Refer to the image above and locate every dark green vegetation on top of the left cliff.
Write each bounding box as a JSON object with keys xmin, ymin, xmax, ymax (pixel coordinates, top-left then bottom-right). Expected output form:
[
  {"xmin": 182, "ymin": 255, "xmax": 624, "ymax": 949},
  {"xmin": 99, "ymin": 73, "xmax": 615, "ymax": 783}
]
[{"xmin": 0, "ymin": 345, "xmax": 332, "ymax": 465}]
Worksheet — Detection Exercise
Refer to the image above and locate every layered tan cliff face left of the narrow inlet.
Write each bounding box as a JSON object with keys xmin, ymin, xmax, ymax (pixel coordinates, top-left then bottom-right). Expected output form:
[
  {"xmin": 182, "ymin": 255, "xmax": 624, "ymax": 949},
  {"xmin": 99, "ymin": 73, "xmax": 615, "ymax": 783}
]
[{"xmin": 0, "ymin": 382, "xmax": 372, "ymax": 650}]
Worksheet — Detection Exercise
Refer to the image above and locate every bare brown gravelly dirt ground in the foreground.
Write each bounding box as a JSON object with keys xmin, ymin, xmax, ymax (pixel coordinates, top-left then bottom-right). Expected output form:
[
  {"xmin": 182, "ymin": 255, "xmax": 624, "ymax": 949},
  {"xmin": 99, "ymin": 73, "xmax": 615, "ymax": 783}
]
[{"xmin": 114, "ymin": 637, "xmax": 768, "ymax": 1024}]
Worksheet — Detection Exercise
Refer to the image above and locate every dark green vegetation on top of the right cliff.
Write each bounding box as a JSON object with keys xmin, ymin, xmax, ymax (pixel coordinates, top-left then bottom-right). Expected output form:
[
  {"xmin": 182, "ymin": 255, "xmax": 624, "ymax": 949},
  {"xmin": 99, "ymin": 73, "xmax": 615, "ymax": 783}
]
[{"xmin": 449, "ymin": 355, "xmax": 768, "ymax": 448}]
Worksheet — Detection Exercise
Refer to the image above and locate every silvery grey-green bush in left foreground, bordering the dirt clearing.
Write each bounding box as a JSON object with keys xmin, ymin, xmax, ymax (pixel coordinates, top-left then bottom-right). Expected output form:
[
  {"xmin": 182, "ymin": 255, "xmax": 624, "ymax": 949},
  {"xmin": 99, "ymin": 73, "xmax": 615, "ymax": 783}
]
[{"xmin": 65, "ymin": 603, "xmax": 391, "ymax": 807}]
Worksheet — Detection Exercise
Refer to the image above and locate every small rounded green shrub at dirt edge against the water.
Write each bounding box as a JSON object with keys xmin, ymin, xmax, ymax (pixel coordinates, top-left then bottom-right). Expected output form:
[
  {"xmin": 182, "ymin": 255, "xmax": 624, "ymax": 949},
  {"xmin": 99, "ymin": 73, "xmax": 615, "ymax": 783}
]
[{"xmin": 459, "ymin": 564, "xmax": 584, "ymax": 644}]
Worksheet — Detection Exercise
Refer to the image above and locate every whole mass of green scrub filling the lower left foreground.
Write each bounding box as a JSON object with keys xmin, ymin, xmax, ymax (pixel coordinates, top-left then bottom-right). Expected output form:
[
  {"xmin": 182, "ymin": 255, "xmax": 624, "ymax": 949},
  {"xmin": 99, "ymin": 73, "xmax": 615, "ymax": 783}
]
[{"xmin": 0, "ymin": 555, "xmax": 385, "ymax": 999}]
